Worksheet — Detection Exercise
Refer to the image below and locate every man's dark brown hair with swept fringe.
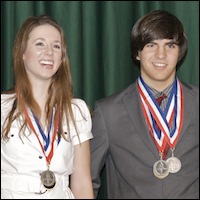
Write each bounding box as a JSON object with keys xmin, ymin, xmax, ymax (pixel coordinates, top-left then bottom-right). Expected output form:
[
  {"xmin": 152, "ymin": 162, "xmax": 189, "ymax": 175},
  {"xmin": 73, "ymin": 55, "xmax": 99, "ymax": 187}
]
[{"xmin": 131, "ymin": 10, "xmax": 187, "ymax": 67}]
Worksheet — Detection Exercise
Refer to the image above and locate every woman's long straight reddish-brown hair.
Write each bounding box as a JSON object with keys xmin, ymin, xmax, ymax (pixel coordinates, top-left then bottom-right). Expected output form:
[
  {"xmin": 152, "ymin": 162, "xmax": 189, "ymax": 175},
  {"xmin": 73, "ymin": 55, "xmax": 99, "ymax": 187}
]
[{"xmin": 2, "ymin": 15, "xmax": 79, "ymax": 139}]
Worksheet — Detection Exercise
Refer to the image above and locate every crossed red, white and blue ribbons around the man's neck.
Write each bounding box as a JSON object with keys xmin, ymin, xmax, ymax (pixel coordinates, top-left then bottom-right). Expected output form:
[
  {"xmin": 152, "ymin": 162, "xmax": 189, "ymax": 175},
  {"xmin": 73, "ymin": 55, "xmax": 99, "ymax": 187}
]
[{"xmin": 138, "ymin": 76, "xmax": 184, "ymax": 152}]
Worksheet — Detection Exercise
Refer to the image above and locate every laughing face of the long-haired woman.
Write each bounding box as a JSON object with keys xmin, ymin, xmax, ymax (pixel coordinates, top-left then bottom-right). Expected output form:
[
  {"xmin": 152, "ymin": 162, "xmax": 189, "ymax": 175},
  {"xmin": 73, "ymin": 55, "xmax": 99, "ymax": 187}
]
[{"xmin": 23, "ymin": 24, "xmax": 62, "ymax": 81}]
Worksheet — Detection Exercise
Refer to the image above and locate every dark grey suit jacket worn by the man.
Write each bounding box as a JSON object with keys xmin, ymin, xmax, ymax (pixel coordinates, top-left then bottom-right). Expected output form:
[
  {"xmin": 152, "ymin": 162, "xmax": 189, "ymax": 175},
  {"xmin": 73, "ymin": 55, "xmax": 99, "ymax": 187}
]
[{"xmin": 91, "ymin": 79, "xmax": 199, "ymax": 199}]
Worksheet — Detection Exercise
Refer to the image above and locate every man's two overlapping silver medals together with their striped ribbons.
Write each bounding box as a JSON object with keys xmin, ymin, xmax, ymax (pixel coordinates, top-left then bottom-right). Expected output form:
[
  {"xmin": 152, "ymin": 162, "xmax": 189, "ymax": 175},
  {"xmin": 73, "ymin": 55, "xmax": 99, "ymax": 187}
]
[{"xmin": 138, "ymin": 76, "xmax": 184, "ymax": 179}]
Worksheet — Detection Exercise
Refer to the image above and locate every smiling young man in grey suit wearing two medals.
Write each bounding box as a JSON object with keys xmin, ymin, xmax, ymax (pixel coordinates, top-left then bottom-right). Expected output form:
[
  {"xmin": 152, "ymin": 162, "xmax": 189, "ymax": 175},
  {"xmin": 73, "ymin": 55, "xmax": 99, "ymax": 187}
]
[{"xmin": 91, "ymin": 10, "xmax": 199, "ymax": 199}]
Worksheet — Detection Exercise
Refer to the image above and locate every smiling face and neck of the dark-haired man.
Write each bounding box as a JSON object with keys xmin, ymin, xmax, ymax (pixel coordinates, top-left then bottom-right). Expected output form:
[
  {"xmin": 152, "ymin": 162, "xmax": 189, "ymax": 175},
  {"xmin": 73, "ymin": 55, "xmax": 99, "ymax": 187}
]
[{"xmin": 137, "ymin": 39, "xmax": 179, "ymax": 90}]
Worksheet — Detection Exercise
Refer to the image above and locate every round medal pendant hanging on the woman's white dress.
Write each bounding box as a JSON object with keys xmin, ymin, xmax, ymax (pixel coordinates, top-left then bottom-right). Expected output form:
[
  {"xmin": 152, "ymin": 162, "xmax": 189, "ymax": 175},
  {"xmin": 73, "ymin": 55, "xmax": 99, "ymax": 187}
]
[{"xmin": 40, "ymin": 170, "xmax": 56, "ymax": 189}]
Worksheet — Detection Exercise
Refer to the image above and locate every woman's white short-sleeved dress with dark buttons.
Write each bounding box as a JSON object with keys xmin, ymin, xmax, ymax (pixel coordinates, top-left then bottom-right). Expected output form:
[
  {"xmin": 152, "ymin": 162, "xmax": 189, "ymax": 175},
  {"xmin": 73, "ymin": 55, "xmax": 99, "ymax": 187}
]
[{"xmin": 1, "ymin": 94, "xmax": 93, "ymax": 199}]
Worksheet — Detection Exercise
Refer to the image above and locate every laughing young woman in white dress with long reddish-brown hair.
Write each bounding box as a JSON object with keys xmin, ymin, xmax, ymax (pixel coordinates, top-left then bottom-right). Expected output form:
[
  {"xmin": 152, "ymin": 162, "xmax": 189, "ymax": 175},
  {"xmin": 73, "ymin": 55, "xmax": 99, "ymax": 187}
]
[{"xmin": 1, "ymin": 16, "xmax": 93, "ymax": 199}]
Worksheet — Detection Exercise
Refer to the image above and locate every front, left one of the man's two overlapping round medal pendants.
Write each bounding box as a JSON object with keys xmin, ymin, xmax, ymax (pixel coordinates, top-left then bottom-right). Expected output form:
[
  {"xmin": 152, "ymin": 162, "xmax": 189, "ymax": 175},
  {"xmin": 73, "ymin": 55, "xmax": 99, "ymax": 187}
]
[{"xmin": 153, "ymin": 160, "xmax": 169, "ymax": 179}]
